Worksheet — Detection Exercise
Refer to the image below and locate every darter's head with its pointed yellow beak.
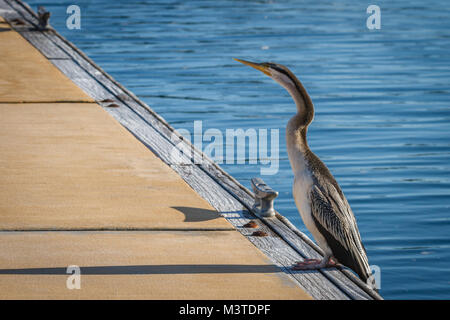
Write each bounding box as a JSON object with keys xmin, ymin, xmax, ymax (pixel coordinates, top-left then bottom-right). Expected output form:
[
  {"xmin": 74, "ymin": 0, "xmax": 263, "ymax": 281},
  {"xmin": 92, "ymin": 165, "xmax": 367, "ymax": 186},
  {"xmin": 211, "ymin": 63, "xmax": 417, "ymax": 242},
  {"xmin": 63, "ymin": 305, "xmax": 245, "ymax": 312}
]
[{"xmin": 234, "ymin": 59, "xmax": 299, "ymax": 91}]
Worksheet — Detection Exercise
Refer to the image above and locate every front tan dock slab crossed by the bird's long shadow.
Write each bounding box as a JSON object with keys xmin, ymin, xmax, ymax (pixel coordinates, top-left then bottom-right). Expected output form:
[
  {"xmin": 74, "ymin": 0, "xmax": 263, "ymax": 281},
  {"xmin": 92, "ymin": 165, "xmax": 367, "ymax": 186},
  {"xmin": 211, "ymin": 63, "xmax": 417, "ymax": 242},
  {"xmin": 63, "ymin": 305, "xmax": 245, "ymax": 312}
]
[{"xmin": 0, "ymin": 230, "xmax": 309, "ymax": 300}]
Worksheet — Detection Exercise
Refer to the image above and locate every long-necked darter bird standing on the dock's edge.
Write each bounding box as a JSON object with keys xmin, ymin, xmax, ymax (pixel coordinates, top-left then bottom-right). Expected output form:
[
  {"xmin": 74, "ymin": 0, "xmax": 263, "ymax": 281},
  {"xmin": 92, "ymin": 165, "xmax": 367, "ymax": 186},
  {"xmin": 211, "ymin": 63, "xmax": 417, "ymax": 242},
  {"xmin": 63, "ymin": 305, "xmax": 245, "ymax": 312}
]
[{"xmin": 235, "ymin": 59, "xmax": 375, "ymax": 289}]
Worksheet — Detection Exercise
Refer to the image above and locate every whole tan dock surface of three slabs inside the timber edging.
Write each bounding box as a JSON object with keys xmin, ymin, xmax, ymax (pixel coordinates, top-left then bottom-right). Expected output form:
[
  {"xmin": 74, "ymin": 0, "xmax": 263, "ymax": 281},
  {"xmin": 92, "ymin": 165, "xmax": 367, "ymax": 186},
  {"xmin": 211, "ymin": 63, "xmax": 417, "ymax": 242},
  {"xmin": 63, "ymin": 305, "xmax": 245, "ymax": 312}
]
[{"xmin": 0, "ymin": 18, "xmax": 311, "ymax": 299}]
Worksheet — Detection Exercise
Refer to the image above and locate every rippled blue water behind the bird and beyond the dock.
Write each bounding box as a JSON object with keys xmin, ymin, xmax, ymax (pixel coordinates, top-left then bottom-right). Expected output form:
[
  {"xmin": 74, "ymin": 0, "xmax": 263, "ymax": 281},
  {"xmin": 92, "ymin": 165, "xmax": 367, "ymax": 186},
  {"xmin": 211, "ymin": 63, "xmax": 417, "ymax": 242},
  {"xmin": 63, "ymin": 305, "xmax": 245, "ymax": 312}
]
[{"xmin": 25, "ymin": 0, "xmax": 450, "ymax": 299}]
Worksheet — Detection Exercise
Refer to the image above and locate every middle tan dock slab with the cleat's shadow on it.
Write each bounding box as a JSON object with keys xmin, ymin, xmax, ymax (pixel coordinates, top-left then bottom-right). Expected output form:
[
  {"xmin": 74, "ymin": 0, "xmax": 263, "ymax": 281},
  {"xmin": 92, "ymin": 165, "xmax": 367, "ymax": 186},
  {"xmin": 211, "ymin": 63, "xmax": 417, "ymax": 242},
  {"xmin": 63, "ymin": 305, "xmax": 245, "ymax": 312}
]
[{"xmin": 0, "ymin": 104, "xmax": 236, "ymax": 231}]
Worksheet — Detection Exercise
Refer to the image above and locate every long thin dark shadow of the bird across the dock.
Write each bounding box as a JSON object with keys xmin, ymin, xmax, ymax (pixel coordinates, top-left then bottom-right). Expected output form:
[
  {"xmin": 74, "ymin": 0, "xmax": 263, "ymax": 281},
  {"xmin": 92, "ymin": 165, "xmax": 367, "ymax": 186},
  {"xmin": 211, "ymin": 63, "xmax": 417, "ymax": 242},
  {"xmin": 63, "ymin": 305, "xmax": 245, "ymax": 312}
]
[{"xmin": 0, "ymin": 264, "xmax": 282, "ymax": 275}]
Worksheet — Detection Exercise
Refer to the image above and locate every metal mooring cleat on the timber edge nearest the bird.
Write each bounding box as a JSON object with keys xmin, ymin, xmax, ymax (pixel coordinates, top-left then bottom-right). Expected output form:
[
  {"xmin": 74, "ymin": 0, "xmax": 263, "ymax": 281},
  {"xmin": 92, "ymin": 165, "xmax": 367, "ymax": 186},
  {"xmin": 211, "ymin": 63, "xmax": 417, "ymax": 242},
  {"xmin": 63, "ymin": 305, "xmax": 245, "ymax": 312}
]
[{"xmin": 251, "ymin": 178, "xmax": 278, "ymax": 218}]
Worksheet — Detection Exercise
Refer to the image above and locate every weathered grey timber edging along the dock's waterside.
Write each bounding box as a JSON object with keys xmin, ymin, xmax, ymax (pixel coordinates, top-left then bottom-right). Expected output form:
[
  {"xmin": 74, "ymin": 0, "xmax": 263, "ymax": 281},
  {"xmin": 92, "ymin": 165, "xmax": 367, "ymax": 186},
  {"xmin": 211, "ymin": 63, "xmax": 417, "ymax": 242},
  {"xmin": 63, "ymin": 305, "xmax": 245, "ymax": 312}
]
[{"xmin": 0, "ymin": 0, "xmax": 382, "ymax": 300}]
